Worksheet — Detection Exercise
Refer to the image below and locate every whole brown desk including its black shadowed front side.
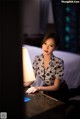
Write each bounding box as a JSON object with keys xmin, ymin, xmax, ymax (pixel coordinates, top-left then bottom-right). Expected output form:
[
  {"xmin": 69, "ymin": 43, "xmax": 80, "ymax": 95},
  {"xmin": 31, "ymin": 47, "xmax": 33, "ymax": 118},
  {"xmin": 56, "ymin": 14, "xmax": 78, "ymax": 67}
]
[{"xmin": 25, "ymin": 89, "xmax": 64, "ymax": 119}]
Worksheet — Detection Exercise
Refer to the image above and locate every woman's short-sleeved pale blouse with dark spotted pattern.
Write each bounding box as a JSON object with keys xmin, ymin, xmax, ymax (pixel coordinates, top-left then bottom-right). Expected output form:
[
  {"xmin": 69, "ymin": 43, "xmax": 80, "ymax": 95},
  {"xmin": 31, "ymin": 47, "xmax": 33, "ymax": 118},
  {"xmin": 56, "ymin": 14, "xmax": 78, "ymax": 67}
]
[{"xmin": 33, "ymin": 54, "xmax": 64, "ymax": 85}]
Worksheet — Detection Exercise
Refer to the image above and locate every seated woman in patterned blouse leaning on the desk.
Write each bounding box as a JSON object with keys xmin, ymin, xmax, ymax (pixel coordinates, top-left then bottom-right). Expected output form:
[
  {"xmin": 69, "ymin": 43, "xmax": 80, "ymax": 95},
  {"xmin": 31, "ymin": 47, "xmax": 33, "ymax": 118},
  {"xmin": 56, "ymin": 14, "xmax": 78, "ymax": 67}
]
[{"xmin": 26, "ymin": 33, "xmax": 69, "ymax": 102}]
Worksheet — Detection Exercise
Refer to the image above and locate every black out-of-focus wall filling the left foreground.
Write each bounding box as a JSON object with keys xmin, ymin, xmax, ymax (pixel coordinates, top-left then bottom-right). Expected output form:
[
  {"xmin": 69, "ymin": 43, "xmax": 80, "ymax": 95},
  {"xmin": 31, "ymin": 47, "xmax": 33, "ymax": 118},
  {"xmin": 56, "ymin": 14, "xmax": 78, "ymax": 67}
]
[{"xmin": 0, "ymin": 0, "xmax": 24, "ymax": 119}]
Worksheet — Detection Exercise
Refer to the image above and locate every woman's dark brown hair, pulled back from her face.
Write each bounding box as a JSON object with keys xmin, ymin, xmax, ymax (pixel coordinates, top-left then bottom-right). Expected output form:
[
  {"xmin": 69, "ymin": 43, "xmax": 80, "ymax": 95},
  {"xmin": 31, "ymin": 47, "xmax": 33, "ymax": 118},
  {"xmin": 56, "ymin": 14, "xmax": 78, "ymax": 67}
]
[{"xmin": 42, "ymin": 33, "xmax": 60, "ymax": 47}]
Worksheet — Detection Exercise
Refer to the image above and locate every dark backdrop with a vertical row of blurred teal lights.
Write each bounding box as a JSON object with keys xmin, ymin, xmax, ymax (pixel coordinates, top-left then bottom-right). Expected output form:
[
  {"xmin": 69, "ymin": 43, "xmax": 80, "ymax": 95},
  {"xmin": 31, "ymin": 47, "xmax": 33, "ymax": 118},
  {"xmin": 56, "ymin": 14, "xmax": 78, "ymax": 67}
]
[{"xmin": 52, "ymin": 0, "xmax": 80, "ymax": 54}]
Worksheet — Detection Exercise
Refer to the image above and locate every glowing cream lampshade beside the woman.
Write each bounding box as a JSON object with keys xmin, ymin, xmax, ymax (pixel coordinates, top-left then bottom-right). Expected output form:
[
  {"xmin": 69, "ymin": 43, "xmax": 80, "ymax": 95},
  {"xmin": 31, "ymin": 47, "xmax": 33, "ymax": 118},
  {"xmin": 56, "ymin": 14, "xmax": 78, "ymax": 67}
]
[{"xmin": 22, "ymin": 47, "xmax": 35, "ymax": 82}]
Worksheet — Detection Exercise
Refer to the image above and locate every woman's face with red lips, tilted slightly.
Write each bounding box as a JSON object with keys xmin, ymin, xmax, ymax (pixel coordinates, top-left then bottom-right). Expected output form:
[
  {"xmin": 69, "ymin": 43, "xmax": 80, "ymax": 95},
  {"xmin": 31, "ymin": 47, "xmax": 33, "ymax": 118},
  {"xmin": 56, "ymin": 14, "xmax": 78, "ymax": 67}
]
[{"xmin": 42, "ymin": 38, "xmax": 56, "ymax": 55}]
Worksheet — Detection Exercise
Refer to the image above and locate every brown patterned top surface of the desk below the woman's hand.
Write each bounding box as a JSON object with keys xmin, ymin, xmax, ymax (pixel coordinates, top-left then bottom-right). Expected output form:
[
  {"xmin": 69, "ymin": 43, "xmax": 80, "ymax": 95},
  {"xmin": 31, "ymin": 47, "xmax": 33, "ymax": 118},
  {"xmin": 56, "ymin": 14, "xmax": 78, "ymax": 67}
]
[{"xmin": 25, "ymin": 89, "xmax": 64, "ymax": 118}]
